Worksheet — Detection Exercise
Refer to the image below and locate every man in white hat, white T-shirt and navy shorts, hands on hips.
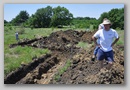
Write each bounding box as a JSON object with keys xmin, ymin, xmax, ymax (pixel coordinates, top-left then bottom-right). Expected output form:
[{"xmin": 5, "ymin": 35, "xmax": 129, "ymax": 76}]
[{"xmin": 92, "ymin": 19, "xmax": 119, "ymax": 70}]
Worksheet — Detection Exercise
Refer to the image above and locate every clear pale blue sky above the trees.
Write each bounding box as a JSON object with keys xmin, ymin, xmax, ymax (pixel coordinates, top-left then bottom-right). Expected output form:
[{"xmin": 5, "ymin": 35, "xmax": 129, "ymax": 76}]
[{"xmin": 4, "ymin": 3, "xmax": 124, "ymax": 21}]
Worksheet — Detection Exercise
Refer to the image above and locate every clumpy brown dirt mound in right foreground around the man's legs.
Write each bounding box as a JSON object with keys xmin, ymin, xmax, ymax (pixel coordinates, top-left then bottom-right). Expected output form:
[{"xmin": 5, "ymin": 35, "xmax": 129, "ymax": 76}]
[{"xmin": 50, "ymin": 47, "xmax": 124, "ymax": 84}]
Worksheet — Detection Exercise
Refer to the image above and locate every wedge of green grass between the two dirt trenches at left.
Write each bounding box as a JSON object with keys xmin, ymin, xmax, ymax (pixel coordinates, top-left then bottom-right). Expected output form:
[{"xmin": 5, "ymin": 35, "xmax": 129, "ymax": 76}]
[{"xmin": 4, "ymin": 46, "xmax": 50, "ymax": 75}]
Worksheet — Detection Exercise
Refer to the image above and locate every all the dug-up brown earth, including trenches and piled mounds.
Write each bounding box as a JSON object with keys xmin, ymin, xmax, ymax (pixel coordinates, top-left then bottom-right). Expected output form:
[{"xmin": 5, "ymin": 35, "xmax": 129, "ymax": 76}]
[{"xmin": 4, "ymin": 30, "xmax": 124, "ymax": 84}]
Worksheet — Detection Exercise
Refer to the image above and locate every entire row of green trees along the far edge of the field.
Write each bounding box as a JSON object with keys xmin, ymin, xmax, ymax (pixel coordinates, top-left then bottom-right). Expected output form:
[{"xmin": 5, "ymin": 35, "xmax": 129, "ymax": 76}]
[{"xmin": 4, "ymin": 6, "xmax": 124, "ymax": 30}]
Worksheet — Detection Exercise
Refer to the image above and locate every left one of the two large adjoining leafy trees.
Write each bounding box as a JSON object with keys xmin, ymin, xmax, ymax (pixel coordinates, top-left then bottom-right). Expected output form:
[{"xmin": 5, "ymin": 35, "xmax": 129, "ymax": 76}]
[{"xmin": 28, "ymin": 6, "xmax": 52, "ymax": 28}]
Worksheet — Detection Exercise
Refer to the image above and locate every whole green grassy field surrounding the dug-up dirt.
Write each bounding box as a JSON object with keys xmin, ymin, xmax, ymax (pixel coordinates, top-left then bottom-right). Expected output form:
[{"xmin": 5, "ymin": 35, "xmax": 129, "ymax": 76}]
[{"xmin": 4, "ymin": 27, "xmax": 124, "ymax": 76}]
